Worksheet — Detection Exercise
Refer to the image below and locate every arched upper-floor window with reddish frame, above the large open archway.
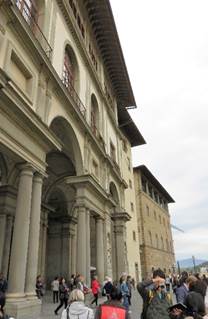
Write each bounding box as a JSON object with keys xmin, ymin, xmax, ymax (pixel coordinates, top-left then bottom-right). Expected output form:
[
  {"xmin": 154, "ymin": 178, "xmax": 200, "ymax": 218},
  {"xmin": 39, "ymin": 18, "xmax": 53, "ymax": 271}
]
[{"xmin": 62, "ymin": 41, "xmax": 80, "ymax": 94}]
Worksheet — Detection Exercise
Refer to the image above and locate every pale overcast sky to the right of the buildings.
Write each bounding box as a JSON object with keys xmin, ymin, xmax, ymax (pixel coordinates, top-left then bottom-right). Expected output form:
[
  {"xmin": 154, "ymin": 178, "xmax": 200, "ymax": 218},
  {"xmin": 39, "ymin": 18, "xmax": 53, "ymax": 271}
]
[{"xmin": 111, "ymin": 0, "xmax": 208, "ymax": 259}]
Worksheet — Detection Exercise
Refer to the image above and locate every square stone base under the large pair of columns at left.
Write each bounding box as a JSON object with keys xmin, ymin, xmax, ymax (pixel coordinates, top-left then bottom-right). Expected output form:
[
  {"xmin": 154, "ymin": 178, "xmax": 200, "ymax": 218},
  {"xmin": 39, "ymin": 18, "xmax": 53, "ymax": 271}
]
[{"xmin": 5, "ymin": 298, "xmax": 41, "ymax": 319}]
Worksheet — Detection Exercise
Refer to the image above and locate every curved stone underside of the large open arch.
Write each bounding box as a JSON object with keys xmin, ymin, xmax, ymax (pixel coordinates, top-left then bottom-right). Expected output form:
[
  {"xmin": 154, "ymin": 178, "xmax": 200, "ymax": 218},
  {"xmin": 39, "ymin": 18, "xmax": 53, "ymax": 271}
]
[{"xmin": 50, "ymin": 116, "xmax": 83, "ymax": 175}]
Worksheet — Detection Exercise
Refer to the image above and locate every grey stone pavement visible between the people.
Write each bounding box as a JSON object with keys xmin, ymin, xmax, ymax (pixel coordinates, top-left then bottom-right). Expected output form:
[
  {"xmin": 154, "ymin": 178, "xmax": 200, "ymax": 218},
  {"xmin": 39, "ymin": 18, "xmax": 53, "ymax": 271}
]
[{"xmin": 39, "ymin": 290, "xmax": 142, "ymax": 319}]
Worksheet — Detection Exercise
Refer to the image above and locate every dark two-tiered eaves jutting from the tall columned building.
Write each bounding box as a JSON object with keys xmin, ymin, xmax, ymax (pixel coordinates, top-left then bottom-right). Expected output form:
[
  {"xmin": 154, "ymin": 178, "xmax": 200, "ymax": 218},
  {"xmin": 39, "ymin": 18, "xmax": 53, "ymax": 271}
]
[{"xmin": 84, "ymin": 0, "xmax": 146, "ymax": 146}]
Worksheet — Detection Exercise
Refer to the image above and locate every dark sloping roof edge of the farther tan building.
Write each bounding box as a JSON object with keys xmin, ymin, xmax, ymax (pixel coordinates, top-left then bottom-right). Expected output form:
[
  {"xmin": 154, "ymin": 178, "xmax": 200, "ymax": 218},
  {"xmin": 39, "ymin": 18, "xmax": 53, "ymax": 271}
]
[{"xmin": 134, "ymin": 165, "xmax": 175, "ymax": 203}]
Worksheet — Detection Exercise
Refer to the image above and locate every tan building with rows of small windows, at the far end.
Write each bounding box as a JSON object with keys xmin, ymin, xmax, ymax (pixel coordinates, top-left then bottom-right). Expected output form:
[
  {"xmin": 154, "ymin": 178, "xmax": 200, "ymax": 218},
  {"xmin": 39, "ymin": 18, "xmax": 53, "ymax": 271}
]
[{"xmin": 134, "ymin": 165, "xmax": 175, "ymax": 278}]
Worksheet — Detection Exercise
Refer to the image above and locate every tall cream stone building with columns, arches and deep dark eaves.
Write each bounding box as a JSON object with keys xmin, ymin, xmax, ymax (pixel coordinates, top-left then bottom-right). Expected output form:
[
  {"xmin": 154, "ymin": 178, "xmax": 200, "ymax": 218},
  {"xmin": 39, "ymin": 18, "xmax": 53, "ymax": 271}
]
[{"xmin": 0, "ymin": 0, "xmax": 145, "ymax": 319}]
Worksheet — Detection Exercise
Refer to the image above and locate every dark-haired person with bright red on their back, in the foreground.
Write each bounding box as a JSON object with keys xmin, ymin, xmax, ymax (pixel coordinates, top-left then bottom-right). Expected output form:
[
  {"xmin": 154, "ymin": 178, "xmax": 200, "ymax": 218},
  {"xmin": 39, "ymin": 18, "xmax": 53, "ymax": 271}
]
[{"xmin": 95, "ymin": 286, "xmax": 130, "ymax": 319}]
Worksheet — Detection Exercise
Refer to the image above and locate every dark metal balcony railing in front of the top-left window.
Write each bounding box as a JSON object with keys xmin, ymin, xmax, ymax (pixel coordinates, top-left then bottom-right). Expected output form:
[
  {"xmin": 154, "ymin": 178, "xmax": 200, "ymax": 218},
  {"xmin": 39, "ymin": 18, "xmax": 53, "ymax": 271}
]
[{"xmin": 15, "ymin": 0, "xmax": 52, "ymax": 58}]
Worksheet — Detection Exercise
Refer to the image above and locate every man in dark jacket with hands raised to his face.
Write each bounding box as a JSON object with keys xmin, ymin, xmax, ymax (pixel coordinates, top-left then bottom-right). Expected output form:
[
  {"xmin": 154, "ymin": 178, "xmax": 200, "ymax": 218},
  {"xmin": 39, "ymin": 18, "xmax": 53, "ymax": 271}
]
[{"xmin": 137, "ymin": 269, "xmax": 171, "ymax": 319}]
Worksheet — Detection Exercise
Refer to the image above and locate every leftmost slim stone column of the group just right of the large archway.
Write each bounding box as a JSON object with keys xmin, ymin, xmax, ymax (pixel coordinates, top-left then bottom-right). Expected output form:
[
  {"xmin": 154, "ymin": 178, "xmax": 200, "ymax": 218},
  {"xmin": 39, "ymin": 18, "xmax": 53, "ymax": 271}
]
[{"xmin": 77, "ymin": 206, "xmax": 87, "ymax": 278}]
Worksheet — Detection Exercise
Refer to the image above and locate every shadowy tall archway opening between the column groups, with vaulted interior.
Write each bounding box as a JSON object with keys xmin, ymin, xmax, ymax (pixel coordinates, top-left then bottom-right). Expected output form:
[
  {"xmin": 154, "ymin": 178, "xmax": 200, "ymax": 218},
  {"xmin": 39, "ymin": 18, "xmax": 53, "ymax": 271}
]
[{"xmin": 39, "ymin": 118, "xmax": 82, "ymax": 287}]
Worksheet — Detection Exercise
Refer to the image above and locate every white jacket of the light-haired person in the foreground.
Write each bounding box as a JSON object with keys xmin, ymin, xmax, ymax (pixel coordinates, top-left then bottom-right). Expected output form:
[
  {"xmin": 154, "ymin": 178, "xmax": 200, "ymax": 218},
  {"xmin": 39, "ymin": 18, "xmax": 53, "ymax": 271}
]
[{"xmin": 61, "ymin": 301, "xmax": 94, "ymax": 319}]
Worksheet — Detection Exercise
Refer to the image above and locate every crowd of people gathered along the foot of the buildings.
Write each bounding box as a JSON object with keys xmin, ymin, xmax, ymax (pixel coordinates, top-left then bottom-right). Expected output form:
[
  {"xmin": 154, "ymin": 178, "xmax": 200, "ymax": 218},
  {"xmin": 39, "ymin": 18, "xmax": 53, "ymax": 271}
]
[{"xmin": 0, "ymin": 269, "xmax": 208, "ymax": 319}]
